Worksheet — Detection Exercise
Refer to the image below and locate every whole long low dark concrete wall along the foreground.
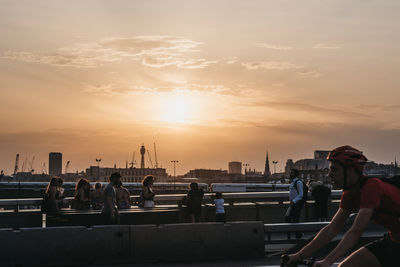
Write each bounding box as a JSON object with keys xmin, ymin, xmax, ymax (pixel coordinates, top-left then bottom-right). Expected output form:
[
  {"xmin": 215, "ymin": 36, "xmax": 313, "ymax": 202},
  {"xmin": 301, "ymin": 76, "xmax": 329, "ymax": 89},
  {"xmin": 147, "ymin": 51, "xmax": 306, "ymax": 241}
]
[{"xmin": 0, "ymin": 222, "xmax": 264, "ymax": 266}]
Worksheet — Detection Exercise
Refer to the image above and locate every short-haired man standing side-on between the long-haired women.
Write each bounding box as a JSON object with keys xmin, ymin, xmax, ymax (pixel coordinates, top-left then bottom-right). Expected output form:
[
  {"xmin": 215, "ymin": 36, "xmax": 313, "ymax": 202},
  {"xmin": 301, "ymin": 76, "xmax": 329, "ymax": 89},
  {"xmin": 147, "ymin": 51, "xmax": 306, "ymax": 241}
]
[{"xmin": 101, "ymin": 172, "xmax": 121, "ymax": 224}]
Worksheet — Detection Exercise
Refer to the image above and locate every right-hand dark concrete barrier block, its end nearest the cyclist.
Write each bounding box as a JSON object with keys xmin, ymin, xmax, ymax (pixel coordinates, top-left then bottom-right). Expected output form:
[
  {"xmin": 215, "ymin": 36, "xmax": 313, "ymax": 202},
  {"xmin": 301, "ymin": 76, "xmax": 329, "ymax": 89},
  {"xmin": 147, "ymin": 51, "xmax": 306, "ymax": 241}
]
[{"xmin": 131, "ymin": 222, "xmax": 264, "ymax": 262}]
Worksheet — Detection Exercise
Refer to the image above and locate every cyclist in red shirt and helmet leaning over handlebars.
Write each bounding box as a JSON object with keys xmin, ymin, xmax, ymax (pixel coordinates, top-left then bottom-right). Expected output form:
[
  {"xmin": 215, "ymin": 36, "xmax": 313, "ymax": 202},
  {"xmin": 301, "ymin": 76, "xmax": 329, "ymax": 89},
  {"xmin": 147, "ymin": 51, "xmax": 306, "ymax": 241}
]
[{"xmin": 287, "ymin": 146, "xmax": 400, "ymax": 267}]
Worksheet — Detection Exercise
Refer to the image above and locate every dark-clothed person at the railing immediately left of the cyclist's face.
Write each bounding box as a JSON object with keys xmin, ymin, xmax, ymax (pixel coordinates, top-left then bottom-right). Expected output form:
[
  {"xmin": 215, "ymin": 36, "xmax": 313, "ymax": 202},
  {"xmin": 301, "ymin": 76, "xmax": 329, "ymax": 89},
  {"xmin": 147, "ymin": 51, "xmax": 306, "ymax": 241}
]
[{"xmin": 309, "ymin": 181, "xmax": 331, "ymax": 222}]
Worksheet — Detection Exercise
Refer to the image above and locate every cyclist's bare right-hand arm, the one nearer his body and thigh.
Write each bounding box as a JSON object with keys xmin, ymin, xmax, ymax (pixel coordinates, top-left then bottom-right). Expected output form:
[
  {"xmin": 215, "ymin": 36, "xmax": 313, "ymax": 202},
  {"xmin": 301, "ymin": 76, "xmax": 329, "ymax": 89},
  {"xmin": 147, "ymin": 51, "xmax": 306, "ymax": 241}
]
[{"xmin": 324, "ymin": 208, "xmax": 374, "ymax": 264}]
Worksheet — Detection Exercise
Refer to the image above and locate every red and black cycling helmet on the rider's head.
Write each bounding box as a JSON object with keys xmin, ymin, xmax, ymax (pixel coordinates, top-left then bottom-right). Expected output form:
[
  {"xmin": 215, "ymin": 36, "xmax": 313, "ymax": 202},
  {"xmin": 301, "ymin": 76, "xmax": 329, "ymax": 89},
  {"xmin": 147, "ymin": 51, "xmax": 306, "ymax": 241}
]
[{"xmin": 326, "ymin": 146, "xmax": 368, "ymax": 173}]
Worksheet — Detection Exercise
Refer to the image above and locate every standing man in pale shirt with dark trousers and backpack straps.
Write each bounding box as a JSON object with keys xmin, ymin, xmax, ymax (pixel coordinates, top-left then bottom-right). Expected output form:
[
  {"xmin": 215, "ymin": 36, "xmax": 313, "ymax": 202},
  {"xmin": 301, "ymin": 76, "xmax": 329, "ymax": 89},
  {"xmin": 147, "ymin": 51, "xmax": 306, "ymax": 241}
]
[{"xmin": 285, "ymin": 169, "xmax": 305, "ymax": 223}]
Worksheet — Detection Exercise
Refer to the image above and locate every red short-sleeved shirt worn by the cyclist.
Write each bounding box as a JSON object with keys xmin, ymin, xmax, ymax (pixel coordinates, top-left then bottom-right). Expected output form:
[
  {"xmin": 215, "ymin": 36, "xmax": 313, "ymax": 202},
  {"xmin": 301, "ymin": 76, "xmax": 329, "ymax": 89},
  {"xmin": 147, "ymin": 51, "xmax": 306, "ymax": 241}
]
[{"xmin": 340, "ymin": 178, "xmax": 400, "ymax": 243}]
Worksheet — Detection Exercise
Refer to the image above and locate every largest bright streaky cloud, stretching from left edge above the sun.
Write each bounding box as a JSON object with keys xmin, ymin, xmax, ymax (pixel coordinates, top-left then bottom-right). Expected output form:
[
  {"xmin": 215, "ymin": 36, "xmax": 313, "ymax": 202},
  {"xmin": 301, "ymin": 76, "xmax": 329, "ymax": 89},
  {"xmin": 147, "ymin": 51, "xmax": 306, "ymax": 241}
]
[{"xmin": 0, "ymin": 35, "xmax": 217, "ymax": 69}]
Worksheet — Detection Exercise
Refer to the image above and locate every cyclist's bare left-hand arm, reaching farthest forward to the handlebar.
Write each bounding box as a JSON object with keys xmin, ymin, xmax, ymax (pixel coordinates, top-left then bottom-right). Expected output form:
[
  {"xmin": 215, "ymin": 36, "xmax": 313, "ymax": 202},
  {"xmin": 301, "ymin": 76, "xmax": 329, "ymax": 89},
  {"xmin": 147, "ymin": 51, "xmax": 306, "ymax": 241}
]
[{"xmin": 294, "ymin": 209, "xmax": 350, "ymax": 259}]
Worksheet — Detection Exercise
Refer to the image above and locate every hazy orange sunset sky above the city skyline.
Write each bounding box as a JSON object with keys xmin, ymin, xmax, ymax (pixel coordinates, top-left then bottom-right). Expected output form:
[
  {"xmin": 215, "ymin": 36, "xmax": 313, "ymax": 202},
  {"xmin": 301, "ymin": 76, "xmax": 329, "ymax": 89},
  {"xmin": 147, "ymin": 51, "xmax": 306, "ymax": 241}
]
[{"xmin": 0, "ymin": 0, "xmax": 400, "ymax": 177}]
